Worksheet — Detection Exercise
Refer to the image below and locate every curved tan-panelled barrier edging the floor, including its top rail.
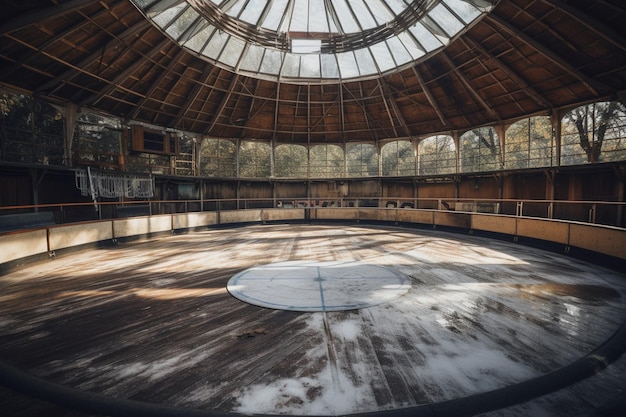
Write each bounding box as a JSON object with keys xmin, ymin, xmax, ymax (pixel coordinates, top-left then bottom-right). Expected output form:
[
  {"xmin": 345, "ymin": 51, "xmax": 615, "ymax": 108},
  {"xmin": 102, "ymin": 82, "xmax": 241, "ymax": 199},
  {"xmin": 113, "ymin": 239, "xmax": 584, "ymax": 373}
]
[{"xmin": 0, "ymin": 198, "xmax": 626, "ymax": 271}]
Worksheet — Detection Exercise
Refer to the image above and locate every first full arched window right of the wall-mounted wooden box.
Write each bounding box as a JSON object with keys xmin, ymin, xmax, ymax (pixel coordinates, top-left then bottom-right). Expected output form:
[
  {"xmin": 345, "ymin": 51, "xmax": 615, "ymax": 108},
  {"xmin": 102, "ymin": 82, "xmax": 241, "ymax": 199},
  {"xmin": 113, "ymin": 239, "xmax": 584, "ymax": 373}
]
[{"xmin": 200, "ymin": 139, "xmax": 237, "ymax": 178}]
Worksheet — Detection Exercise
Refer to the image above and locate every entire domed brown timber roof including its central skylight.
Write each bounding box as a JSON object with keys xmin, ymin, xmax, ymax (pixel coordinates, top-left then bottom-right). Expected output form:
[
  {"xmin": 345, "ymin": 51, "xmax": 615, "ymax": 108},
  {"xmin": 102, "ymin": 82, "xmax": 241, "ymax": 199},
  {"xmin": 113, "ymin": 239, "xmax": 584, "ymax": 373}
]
[{"xmin": 0, "ymin": 0, "xmax": 626, "ymax": 144}]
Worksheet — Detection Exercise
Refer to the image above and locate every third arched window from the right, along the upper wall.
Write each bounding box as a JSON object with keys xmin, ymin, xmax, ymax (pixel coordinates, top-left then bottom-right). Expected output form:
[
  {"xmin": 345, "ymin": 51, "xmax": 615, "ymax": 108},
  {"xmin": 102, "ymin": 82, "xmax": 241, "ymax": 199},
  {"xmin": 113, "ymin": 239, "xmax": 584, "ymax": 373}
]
[{"xmin": 459, "ymin": 127, "xmax": 501, "ymax": 172}]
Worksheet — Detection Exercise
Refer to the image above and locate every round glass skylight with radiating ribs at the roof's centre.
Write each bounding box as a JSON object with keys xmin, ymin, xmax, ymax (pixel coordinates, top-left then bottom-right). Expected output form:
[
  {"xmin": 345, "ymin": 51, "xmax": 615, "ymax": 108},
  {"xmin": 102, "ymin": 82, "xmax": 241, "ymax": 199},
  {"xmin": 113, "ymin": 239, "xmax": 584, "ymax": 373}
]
[{"xmin": 132, "ymin": 0, "xmax": 498, "ymax": 82}]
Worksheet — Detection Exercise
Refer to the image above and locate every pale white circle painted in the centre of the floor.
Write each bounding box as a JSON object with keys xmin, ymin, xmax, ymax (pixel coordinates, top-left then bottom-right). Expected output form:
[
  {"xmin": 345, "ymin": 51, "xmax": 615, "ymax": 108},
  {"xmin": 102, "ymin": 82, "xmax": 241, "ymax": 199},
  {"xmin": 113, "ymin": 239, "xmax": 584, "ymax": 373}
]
[{"xmin": 227, "ymin": 261, "xmax": 411, "ymax": 311}]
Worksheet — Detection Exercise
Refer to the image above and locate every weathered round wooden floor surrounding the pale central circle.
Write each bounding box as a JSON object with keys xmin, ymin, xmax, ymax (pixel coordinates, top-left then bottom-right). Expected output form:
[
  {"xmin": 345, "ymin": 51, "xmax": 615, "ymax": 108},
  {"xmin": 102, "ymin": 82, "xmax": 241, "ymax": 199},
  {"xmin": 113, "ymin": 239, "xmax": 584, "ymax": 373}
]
[{"xmin": 0, "ymin": 225, "xmax": 626, "ymax": 416}]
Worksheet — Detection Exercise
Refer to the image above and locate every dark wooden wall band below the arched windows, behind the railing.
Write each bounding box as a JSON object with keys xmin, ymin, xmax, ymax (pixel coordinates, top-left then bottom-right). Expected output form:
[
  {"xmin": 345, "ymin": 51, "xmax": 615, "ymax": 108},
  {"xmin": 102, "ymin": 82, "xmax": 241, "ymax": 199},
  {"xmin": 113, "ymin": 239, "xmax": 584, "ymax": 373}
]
[{"xmin": 0, "ymin": 163, "xmax": 626, "ymax": 225}]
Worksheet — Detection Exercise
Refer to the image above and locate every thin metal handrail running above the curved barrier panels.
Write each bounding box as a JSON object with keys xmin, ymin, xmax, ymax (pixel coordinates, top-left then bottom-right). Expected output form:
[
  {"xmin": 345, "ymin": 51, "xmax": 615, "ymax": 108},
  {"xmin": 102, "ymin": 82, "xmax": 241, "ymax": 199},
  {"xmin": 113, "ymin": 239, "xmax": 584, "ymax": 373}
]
[{"xmin": 0, "ymin": 197, "xmax": 626, "ymax": 226}]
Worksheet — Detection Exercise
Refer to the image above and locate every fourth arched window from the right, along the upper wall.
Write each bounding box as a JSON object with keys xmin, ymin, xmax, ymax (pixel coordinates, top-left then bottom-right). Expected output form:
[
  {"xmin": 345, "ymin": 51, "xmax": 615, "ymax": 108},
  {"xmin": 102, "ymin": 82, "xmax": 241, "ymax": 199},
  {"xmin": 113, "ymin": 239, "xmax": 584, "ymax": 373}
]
[{"xmin": 417, "ymin": 135, "xmax": 456, "ymax": 175}]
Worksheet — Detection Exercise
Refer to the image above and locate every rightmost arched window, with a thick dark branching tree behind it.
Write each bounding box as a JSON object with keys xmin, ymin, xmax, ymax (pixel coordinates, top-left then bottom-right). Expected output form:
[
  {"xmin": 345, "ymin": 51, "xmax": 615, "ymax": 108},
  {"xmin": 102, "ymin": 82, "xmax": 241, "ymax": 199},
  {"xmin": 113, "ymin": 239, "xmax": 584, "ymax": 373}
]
[{"xmin": 561, "ymin": 101, "xmax": 626, "ymax": 165}]
